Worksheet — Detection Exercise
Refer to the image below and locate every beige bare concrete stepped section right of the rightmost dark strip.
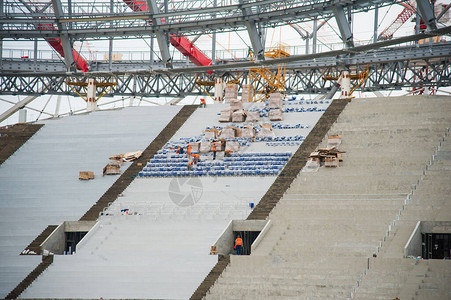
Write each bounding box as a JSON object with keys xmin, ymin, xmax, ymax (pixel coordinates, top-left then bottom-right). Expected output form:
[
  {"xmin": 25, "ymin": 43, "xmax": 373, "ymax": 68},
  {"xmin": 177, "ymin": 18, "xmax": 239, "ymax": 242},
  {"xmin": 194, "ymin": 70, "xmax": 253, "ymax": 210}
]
[{"xmin": 205, "ymin": 97, "xmax": 451, "ymax": 299}]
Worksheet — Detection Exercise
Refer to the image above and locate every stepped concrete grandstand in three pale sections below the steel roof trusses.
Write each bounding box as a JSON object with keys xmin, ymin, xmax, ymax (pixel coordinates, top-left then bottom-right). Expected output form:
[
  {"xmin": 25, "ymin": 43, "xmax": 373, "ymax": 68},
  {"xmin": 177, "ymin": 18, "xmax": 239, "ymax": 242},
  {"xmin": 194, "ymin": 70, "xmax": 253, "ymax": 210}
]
[{"xmin": 0, "ymin": 96, "xmax": 451, "ymax": 299}]
